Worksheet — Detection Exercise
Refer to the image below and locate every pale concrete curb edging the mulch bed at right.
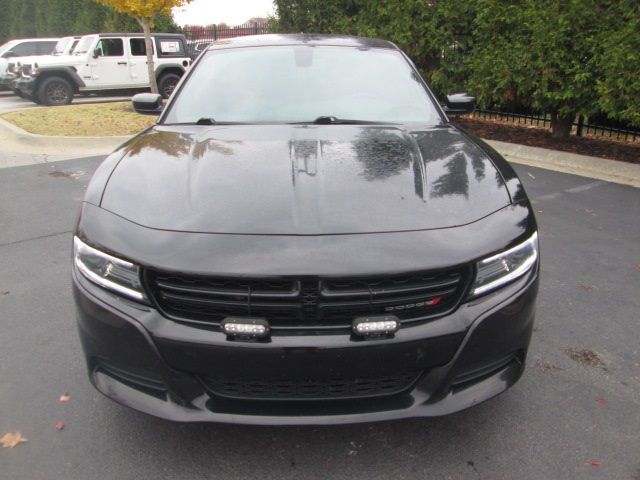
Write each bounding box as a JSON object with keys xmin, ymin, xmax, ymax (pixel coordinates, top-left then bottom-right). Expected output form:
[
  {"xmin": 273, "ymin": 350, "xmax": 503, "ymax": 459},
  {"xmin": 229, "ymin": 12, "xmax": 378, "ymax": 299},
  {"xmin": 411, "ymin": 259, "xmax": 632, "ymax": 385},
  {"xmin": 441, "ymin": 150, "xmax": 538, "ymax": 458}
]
[{"xmin": 485, "ymin": 140, "xmax": 640, "ymax": 188}]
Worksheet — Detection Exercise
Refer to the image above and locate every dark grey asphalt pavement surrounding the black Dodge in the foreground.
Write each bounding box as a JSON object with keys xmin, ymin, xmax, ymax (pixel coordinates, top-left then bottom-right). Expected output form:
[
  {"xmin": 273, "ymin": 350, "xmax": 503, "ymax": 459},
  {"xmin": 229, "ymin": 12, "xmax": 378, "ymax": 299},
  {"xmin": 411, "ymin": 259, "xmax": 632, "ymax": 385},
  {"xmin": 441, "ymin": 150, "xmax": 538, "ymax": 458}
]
[{"xmin": 0, "ymin": 153, "xmax": 640, "ymax": 480}]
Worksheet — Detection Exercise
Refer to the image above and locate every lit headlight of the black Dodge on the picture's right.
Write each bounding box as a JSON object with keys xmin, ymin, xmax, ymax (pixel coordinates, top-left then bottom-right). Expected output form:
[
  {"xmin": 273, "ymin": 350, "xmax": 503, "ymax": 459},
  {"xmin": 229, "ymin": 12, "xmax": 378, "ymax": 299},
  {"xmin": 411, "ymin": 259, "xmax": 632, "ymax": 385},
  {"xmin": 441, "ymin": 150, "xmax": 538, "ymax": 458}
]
[{"xmin": 471, "ymin": 232, "xmax": 538, "ymax": 297}]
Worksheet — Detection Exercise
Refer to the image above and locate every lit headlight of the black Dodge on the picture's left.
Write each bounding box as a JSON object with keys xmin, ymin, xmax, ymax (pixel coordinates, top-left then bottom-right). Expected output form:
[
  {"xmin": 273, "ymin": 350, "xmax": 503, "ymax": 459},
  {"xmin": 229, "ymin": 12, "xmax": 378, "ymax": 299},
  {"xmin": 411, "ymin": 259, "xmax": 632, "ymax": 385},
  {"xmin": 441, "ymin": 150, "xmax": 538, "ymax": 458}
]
[{"xmin": 73, "ymin": 237, "xmax": 147, "ymax": 301}]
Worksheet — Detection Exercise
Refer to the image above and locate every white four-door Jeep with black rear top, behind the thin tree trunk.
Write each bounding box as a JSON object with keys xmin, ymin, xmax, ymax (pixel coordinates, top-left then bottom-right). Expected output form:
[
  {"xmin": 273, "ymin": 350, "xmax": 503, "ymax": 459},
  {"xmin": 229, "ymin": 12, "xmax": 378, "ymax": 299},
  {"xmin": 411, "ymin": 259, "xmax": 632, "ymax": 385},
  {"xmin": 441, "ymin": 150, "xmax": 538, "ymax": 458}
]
[{"xmin": 12, "ymin": 33, "xmax": 191, "ymax": 105}]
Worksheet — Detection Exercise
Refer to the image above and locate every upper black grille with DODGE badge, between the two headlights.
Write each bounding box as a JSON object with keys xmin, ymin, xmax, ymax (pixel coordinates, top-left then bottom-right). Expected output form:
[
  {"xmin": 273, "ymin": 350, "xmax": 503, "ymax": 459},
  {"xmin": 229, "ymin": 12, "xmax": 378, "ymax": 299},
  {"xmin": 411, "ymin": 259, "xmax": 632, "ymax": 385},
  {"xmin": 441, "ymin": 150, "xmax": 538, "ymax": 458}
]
[{"xmin": 145, "ymin": 269, "xmax": 476, "ymax": 333}]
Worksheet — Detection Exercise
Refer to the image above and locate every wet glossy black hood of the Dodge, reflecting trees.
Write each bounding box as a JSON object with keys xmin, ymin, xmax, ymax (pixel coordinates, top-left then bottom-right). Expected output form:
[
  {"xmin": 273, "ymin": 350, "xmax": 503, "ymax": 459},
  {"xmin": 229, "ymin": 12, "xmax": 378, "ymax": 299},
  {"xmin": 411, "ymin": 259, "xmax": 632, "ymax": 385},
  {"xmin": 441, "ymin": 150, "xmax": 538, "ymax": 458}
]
[{"xmin": 100, "ymin": 125, "xmax": 511, "ymax": 235}]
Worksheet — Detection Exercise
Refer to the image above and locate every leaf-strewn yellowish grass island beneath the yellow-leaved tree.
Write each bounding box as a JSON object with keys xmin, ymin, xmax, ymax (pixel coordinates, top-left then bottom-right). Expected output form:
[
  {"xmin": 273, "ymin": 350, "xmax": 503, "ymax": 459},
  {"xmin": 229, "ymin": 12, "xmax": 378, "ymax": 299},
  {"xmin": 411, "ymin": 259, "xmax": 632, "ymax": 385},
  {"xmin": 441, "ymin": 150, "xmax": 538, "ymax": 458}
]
[{"xmin": 1, "ymin": 102, "xmax": 157, "ymax": 137}]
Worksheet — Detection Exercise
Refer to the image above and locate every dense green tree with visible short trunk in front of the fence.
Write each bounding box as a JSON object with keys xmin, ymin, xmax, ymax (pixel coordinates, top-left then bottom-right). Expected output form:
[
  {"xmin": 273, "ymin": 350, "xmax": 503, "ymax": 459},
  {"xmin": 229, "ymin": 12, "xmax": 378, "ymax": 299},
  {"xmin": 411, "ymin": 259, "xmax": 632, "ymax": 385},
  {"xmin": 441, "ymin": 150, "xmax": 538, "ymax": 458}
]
[{"xmin": 463, "ymin": 0, "xmax": 611, "ymax": 137}]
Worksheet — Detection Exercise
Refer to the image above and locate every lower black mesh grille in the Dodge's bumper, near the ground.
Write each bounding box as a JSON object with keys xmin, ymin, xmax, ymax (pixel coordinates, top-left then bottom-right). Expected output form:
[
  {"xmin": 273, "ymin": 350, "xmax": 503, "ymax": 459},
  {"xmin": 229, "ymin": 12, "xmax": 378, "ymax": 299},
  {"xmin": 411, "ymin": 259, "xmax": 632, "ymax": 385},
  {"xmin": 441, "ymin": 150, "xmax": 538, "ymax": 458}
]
[{"xmin": 201, "ymin": 372, "xmax": 420, "ymax": 400}]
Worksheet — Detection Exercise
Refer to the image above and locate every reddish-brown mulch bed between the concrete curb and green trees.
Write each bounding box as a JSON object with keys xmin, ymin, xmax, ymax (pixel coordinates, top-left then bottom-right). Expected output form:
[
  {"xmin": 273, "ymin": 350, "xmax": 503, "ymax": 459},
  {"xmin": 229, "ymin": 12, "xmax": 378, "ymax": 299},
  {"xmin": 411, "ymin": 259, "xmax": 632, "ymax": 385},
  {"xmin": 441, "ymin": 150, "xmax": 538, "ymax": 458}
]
[{"xmin": 453, "ymin": 117, "xmax": 640, "ymax": 164}]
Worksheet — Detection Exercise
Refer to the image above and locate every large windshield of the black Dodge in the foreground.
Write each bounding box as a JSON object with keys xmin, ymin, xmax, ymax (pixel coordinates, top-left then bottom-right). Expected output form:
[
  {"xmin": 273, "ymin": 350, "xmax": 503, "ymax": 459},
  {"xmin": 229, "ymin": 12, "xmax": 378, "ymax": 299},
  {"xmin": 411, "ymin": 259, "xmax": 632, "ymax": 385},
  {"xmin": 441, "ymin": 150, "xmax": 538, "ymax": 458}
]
[{"xmin": 164, "ymin": 45, "xmax": 440, "ymax": 124}]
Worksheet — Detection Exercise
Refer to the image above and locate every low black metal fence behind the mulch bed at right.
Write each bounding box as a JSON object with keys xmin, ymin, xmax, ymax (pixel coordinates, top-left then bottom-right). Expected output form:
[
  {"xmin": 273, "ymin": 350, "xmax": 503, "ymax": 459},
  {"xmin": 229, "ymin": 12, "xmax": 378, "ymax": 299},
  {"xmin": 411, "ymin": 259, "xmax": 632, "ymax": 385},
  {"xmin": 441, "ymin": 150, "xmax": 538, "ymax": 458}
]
[{"xmin": 472, "ymin": 109, "xmax": 640, "ymax": 142}]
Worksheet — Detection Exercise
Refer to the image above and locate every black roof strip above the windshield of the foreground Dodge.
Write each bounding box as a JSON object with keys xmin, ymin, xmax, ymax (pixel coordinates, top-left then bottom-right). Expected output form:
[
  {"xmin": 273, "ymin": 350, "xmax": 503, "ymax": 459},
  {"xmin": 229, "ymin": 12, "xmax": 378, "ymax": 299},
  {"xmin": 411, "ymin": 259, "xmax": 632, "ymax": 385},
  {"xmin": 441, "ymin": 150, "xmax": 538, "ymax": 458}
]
[{"xmin": 209, "ymin": 33, "xmax": 398, "ymax": 50}]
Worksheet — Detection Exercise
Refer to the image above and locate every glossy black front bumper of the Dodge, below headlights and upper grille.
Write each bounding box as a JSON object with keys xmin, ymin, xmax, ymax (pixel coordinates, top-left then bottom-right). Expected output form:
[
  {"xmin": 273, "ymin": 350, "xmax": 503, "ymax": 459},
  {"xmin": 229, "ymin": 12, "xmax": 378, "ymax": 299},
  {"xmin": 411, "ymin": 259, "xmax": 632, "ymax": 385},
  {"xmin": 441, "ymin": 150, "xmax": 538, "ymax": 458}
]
[{"xmin": 73, "ymin": 260, "xmax": 538, "ymax": 425}]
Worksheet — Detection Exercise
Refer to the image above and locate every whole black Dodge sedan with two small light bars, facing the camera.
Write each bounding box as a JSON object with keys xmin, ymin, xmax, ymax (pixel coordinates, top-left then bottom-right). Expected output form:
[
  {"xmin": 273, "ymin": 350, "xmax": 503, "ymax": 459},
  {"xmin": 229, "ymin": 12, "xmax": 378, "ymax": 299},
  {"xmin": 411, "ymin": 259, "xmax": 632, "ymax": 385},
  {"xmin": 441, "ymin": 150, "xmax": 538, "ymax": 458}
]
[{"xmin": 73, "ymin": 34, "xmax": 539, "ymax": 424}]
